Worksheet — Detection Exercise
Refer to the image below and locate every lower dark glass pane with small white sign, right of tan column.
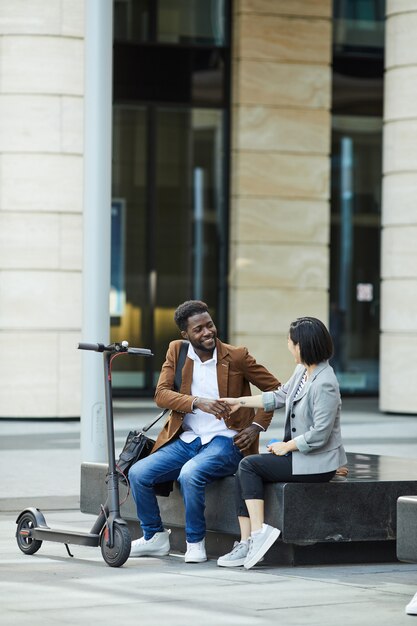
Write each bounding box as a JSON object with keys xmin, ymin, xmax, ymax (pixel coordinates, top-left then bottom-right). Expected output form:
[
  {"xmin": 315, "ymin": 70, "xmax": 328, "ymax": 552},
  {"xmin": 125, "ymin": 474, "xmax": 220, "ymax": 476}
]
[{"xmin": 330, "ymin": 117, "xmax": 382, "ymax": 393}]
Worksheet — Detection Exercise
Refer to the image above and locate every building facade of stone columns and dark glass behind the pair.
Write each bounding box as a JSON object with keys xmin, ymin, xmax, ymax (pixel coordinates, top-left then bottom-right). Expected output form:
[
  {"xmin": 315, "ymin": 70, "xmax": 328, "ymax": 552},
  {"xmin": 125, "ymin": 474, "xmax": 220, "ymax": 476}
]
[{"xmin": 0, "ymin": 0, "xmax": 417, "ymax": 418}]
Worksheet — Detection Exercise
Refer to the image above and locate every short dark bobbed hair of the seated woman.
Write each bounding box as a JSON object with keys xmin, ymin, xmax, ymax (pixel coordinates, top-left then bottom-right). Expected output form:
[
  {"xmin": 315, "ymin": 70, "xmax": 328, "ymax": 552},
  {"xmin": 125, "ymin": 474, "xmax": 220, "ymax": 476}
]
[{"xmin": 290, "ymin": 317, "xmax": 333, "ymax": 365}]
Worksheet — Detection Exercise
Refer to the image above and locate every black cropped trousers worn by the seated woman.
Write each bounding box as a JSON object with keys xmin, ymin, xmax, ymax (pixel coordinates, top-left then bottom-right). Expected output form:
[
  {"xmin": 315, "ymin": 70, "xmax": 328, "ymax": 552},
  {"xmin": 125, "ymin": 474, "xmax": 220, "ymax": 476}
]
[{"xmin": 236, "ymin": 452, "xmax": 336, "ymax": 517}]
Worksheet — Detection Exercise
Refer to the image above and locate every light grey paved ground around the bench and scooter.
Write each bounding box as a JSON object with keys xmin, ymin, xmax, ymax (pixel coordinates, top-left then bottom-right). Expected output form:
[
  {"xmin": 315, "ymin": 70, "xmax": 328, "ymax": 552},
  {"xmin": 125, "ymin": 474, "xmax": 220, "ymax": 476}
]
[{"xmin": 0, "ymin": 399, "xmax": 417, "ymax": 626}]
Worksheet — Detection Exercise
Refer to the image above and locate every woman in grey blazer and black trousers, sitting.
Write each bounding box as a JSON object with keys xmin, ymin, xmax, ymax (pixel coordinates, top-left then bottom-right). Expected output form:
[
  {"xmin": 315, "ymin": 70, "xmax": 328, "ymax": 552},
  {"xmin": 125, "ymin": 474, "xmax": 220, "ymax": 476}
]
[{"xmin": 217, "ymin": 317, "xmax": 346, "ymax": 569}]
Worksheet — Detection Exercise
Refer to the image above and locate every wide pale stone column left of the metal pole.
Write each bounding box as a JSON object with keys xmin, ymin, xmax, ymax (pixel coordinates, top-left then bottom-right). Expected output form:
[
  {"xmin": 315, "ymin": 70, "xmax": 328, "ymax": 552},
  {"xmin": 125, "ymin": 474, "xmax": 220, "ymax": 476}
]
[{"xmin": 0, "ymin": 0, "xmax": 84, "ymax": 417}]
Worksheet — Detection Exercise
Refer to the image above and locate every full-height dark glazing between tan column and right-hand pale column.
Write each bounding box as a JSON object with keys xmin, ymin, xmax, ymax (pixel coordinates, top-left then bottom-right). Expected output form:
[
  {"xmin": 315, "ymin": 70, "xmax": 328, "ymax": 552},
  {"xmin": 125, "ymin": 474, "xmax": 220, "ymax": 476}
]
[{"xmin": 330, "ymin": 0, "xmax": 385, "ymax": 394}]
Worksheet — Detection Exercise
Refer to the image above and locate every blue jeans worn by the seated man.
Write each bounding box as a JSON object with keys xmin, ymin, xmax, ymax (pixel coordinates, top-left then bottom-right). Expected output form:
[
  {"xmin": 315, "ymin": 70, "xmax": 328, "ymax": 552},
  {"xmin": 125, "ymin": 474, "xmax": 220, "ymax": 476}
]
[{"xmin": 129, "ymin": 437, "xmax": 243, "ymax": 543}]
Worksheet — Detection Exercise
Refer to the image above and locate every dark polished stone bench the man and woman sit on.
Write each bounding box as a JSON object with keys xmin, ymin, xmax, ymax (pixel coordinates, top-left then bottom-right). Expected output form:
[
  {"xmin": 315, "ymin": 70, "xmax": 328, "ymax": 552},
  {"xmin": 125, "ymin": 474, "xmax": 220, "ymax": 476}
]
[{"xmin": 81, "ymin": 453, "xmax": 417, "ymax": 565}]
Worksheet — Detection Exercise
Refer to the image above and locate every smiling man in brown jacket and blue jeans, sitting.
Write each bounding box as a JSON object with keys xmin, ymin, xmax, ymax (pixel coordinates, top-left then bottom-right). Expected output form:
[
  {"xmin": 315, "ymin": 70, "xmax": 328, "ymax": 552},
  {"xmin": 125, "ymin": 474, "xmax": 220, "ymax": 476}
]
[{"xmin": 129, "ymin": 300, "xmax": 280, "ymax": 563}]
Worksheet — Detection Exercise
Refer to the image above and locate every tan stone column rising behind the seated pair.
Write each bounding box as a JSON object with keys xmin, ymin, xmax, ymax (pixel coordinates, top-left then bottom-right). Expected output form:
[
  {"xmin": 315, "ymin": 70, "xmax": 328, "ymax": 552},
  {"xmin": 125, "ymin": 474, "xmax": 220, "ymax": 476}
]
[{"xmin": 229, "ymin": 0, "xmax": 332, "ymax": 379}]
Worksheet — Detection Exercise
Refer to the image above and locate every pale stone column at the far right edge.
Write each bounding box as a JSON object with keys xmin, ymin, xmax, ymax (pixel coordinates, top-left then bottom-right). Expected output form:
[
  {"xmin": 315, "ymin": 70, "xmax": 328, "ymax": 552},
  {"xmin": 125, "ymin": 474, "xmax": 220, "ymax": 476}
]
[{"xmin": 379, "ymin": 0, "xmax": 417, "ymax": 413}]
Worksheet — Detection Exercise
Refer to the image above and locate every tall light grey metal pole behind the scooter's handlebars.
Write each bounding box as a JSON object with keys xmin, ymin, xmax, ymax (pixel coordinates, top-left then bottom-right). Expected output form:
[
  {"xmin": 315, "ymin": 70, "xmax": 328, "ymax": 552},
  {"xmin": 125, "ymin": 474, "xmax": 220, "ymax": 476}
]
[{"xmin": 81, "ymin": 0, "xmax": 113, "ymax": 463}]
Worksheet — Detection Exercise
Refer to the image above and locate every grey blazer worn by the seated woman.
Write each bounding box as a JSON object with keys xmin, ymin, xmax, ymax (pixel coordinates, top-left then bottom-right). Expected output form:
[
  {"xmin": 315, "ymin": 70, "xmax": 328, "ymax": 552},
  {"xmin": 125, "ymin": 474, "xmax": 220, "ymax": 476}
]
[{"xmin": 262, "ymin": 361, "xmax": 347, "ymax": 474}]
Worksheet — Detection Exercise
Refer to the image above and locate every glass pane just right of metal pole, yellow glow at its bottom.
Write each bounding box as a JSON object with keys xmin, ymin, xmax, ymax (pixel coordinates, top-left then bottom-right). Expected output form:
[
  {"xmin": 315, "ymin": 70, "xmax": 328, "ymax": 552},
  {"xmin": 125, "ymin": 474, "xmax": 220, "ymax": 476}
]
[{"xmin": 110, "ymin": 106, "xmax": 150, "ymax": 388}]
